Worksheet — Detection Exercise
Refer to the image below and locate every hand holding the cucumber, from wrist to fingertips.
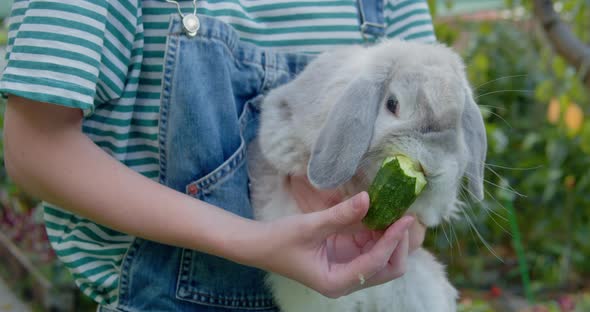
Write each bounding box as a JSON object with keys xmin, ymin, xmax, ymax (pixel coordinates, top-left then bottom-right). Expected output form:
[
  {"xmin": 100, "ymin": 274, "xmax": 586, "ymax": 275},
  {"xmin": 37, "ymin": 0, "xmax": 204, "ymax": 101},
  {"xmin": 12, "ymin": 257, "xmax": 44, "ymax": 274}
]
[{"xmin": 258, "ymin": 192, "xmax": 414, "ymax": 298}]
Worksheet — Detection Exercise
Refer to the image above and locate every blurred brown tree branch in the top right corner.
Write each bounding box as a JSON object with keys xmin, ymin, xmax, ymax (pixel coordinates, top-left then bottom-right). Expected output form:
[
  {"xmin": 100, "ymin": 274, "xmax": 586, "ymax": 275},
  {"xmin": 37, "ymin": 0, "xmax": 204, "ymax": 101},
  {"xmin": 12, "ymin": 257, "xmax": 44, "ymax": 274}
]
[{"xmin": 533, "ymin": 0, "xmax": 590, "ymax": 88}]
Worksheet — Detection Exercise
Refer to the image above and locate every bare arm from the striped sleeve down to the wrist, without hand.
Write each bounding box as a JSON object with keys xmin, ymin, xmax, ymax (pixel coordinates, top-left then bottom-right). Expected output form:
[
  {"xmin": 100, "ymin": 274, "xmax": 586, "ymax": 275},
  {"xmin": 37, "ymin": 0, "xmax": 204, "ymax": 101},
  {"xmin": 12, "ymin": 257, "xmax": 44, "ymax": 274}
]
[{"xmin": 5, "ymin": 97, "xmax": 263, "ymax": 262}]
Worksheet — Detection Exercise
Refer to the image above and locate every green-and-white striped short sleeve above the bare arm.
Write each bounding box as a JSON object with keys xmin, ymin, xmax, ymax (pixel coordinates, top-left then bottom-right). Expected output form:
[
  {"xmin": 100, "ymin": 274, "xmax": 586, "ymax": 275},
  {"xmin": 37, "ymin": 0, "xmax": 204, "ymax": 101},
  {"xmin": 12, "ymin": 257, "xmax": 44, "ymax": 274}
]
[{"xmin": 0, "ymin": 0, "xmax": 137, "ymax": 115}]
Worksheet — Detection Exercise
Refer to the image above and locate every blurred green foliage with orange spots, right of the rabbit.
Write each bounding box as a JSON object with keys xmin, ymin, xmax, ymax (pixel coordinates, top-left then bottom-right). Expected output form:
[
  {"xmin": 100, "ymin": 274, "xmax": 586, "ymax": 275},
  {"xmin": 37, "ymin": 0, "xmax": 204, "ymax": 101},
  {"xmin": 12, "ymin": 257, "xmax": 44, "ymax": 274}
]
[{"xmin": 428, "ymin": 1, "xmax": 590, "ymax": 302}]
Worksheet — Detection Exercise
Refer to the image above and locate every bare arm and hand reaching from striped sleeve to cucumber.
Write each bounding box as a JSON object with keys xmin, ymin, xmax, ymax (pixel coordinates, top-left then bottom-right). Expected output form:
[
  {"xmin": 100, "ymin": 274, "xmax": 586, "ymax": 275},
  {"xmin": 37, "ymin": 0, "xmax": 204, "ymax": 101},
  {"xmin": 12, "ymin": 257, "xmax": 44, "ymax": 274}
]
[{"xmin": 4, "ymin": 96, "xmax": 420, "ymax": 297}]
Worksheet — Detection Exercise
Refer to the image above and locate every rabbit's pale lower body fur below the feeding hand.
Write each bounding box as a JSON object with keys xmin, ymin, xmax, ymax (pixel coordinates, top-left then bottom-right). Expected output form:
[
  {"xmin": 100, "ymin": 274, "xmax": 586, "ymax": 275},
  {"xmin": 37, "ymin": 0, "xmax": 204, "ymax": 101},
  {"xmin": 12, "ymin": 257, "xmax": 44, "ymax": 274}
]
[{"xmin": 268, "ymin": 249, "xmax": 457, "ymax": 312}]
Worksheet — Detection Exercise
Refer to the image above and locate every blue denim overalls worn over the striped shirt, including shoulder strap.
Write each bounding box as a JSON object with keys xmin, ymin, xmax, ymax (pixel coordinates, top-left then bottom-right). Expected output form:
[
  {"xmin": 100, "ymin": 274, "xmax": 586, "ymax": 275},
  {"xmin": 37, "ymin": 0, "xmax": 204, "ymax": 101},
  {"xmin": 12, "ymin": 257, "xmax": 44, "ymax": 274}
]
[{"xmin": 99, "ymin": 0, "xmax": 384, "ymax": 311}]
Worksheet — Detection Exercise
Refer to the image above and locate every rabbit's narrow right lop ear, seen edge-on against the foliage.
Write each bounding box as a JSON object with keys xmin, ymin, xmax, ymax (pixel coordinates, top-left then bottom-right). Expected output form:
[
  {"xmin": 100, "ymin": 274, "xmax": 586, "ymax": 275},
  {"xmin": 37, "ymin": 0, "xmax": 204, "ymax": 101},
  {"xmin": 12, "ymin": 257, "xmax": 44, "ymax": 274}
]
[{"xmin": 462, "ymin": 92, "xmax": 487, "ymax": 201}]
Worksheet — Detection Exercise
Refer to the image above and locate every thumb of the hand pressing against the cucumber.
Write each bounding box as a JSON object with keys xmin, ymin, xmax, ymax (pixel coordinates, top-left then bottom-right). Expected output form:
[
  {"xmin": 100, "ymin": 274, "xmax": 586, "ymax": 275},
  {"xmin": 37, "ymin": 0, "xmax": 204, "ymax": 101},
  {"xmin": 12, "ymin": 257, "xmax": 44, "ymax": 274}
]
[{"xmin": 316, "ymin": 192, "xmax": 369, "ymax": 236}]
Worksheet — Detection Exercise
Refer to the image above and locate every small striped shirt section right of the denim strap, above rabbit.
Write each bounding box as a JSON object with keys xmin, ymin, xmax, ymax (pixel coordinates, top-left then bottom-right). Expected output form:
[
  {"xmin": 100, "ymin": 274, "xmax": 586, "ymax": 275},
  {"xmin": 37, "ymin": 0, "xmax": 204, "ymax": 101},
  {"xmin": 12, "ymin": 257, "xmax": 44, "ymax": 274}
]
[{"xmin": 384, "ymin": 0, "xmax": 436, "ymax": 43}]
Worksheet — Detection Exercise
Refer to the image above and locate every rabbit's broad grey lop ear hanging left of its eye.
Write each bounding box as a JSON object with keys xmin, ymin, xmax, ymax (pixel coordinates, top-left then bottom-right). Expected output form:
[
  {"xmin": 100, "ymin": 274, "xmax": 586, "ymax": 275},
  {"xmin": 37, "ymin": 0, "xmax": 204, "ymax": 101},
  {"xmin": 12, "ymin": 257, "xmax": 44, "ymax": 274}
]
[{"xmin": 307, "ymin": 76, "xmax": 383, "ymax": 189}]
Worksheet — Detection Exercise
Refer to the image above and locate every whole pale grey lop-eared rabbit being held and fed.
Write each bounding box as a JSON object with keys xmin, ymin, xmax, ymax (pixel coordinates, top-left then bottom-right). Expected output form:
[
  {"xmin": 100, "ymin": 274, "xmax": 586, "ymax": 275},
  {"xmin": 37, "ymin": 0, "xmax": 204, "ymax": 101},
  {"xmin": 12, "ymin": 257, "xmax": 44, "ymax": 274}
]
[{"xmin": 248, "ymin": 39, "xmax": 487, "ymax": 312}]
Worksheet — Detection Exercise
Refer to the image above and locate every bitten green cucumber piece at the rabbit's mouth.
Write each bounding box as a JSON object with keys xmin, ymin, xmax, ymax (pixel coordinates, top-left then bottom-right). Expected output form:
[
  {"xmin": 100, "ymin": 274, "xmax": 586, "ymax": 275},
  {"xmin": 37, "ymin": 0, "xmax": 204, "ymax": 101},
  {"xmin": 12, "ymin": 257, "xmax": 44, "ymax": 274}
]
[{"xmin": 363, "ymin": 155, "xmax": 426, "ymax": 230}]
